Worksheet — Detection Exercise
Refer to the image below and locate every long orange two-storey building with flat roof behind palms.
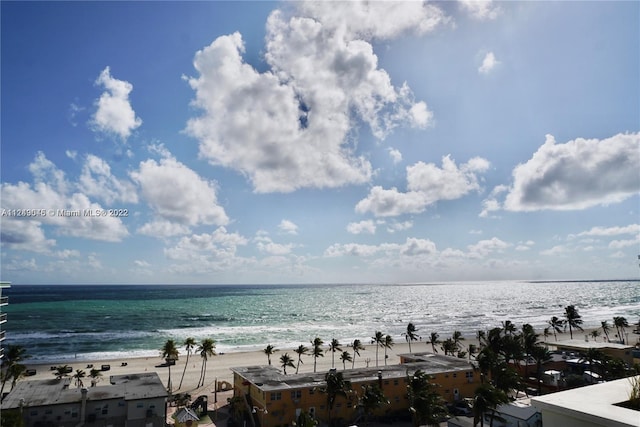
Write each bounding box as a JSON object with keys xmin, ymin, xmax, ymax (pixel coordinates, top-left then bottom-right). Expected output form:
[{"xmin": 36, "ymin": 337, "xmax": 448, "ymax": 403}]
[{"xmin": 231, "ymin": 353, "xmax": 479, "ymax": 427}]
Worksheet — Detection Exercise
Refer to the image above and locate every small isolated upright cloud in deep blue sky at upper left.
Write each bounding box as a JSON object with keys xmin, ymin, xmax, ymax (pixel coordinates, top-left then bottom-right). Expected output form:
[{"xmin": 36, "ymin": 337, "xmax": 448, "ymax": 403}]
[{"xmin": 91, "ymin": 67, "xmax": 142, "ymax": 141}]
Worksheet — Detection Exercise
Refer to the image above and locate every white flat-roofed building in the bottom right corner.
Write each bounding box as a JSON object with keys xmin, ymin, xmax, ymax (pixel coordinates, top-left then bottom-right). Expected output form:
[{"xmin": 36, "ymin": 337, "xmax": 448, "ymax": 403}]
[{"xmin": 531, "ymin": 377, "xmax": 640, "ymax": 427}]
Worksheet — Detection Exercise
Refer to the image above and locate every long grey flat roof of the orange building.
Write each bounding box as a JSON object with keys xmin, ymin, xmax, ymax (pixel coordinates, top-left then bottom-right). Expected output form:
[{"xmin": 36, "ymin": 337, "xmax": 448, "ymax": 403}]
[{"xmin": 231, "ymin": 353, "xmax": 473, "ymax": 391}]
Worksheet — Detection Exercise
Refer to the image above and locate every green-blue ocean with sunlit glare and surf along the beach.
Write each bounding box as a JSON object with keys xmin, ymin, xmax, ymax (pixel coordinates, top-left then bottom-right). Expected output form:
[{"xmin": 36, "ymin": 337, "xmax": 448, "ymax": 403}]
[{"xmin": 3, "ymin": 280, "xmax": 640, "ymax": 363}]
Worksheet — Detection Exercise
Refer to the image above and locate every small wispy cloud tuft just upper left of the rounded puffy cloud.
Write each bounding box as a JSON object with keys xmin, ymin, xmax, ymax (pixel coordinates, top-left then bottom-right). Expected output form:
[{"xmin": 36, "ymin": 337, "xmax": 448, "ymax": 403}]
[{"xmin": 78, "ymin": 154, "xmax": 138, "ymax": 207}]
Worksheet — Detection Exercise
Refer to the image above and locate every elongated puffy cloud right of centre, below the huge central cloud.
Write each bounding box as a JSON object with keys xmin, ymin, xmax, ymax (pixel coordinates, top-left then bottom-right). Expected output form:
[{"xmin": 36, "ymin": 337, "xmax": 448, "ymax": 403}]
[{"xmin": 356, "ymin": 156, "xmax": 490, "ymax": 216}]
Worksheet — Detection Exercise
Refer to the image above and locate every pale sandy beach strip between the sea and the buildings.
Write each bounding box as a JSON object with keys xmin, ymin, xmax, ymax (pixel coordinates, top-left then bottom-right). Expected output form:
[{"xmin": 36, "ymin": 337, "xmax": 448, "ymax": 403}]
[{"xmin": 17, "ymin": 330, "xmax": 637, "ymax": 394}]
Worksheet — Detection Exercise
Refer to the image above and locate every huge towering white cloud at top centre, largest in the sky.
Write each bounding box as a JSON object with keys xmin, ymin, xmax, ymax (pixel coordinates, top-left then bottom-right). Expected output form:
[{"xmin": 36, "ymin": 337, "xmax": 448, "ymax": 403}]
[{"xmin": 186, "ymin": 2, "xmax": 446, "ymax": 193}]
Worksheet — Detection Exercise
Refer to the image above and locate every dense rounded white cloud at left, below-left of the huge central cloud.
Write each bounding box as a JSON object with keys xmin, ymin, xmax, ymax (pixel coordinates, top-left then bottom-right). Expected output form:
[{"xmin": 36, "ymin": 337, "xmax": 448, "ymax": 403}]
[{"xmin": 130, "ymin": 157, "xmax": 229, "ymax": 226}]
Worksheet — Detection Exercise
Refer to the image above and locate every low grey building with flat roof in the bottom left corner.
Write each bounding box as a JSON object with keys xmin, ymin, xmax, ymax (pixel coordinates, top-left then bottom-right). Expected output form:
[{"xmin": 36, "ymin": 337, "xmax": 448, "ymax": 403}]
[{"xmin": 2, "ymin": 372, "xmax": 167, "ymax": 427}]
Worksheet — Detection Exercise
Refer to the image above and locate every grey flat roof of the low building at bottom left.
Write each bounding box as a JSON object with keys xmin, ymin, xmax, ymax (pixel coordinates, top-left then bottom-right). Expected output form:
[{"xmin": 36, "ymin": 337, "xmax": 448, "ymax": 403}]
[{"xmin": 2, "ymin": 372, "xmax": 167, "ymax": 409}]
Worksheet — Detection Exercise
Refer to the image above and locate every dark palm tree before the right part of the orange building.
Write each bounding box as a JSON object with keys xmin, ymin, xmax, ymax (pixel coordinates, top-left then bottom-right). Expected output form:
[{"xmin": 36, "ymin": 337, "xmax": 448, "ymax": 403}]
[{"xmin": 407, "ymin": 370, "xmax": 448, "ymax": 427}]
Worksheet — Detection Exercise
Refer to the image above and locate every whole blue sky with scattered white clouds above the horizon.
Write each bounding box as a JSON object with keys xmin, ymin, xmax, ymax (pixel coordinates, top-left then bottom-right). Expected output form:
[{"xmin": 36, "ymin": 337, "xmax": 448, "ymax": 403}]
[{"xmin": 0, "ymin": 1, "xmax": 640, "ymax": 284}]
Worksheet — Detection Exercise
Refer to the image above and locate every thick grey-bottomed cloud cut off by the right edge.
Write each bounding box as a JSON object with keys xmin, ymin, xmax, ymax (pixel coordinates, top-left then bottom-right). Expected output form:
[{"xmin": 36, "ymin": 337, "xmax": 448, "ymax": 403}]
[{"xmin": 481, "ymin": 133, "xmax": 640, "ymax": 216}]
